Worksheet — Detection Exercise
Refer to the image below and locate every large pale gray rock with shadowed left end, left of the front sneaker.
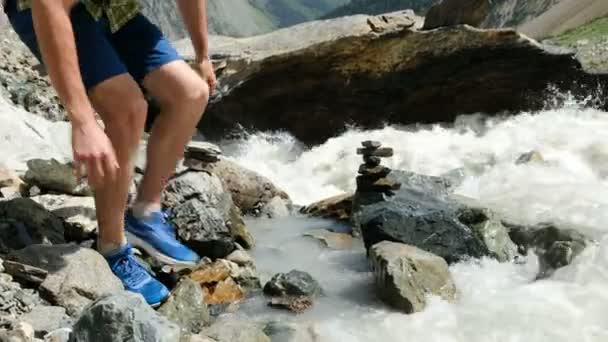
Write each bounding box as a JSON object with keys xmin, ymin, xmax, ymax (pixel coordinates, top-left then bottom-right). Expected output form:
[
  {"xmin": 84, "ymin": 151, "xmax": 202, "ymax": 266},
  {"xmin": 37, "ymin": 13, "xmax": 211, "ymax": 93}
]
[{"xmin": 10, "ymin": 245, "xmax": 123, "ymax": 316}]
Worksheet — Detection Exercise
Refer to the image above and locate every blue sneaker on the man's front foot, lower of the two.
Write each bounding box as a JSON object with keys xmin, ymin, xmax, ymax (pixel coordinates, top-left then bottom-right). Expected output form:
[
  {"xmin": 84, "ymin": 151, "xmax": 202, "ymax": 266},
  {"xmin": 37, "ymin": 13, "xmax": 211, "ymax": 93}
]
[{"xmin": 106, "ymin": 244, "xmax": 169, "ymax": 307}]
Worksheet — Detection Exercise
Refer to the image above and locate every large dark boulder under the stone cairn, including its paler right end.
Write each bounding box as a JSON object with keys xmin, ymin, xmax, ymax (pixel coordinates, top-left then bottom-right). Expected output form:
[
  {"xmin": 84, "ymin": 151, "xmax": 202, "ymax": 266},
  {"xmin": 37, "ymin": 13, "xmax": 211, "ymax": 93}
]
[{"xmin": 353, "ymin": 171, "xmax": 515, "ymax": 263}]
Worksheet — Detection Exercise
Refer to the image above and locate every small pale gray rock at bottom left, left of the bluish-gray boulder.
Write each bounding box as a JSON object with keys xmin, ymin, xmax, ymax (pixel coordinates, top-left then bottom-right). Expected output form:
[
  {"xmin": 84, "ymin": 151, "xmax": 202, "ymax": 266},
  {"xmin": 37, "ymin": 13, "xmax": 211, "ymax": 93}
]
[{"xmin": 19, "ymin": 306, "xmax": 72, "ymax": 337}]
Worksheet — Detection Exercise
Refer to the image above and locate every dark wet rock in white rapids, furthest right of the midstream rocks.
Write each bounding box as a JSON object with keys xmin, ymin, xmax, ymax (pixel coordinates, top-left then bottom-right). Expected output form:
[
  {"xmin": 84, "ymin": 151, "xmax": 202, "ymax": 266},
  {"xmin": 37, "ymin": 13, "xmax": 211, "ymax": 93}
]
[{"xmin": 506, "ymin": 223, "xmax": 591, "ymax": 278}]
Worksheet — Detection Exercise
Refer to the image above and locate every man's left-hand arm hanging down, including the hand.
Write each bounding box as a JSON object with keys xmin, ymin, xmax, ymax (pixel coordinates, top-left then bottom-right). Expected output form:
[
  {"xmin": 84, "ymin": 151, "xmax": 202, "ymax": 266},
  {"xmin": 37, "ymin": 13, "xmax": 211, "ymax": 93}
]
[{"xmin": 32, "ymin": 0, "xmax": 119, "ymax": 187}]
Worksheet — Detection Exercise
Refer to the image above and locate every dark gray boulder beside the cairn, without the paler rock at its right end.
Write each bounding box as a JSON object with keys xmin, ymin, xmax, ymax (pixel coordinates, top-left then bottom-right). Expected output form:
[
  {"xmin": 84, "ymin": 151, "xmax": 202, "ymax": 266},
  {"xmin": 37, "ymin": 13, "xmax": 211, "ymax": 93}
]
[{"xmin": 355, "ymin": 171, "xmax": 490, "ymax": 263}]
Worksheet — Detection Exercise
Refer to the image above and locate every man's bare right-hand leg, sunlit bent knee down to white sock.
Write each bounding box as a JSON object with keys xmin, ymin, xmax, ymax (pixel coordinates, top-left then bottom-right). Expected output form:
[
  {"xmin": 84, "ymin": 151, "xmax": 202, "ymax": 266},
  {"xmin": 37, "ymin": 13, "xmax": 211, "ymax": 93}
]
[{"xmin": 137, "ymin": 61, "xmax": 209, "ymax": 207}]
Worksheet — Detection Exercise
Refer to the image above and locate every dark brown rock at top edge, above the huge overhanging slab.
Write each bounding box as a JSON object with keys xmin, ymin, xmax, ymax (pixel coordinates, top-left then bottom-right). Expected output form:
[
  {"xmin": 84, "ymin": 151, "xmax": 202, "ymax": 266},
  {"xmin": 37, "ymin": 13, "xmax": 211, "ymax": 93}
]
[{"xmin": 424, "ymin": 0, "xmax": 491, "ymax": 30}]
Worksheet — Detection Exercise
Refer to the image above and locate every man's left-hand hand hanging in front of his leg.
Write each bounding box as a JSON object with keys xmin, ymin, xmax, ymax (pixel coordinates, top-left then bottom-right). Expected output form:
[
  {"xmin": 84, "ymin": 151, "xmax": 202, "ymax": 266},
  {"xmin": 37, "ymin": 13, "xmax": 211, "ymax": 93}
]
[{"xmin": 72, "ymin": 120, "xmax": 120, "ymax": 189}]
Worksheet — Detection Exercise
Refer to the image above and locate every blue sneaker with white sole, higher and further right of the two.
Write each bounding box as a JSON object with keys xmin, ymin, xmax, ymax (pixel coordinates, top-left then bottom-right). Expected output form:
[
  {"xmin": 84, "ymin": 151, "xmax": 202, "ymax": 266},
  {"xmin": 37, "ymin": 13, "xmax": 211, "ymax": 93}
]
[{"xmin": 125, "ymin": 211, "xmax": 200, "ymax": 266}]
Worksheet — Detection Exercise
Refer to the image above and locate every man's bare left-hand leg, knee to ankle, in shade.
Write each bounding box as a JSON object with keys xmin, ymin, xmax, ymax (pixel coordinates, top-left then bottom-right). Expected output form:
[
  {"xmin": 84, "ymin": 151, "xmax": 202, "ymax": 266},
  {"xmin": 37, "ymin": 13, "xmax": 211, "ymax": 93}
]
[{"xmin": 89, "ymin": 74, "xmax": 147, "ymax": 253}]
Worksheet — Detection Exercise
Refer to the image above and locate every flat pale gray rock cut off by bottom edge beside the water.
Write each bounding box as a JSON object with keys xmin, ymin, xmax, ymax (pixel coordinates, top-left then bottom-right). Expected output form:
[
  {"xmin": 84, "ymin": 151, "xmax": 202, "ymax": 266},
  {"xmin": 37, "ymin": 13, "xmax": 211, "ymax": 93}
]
[{"xmin": 205, "ymin": 318, "xmax": 271, "ymax": 342}]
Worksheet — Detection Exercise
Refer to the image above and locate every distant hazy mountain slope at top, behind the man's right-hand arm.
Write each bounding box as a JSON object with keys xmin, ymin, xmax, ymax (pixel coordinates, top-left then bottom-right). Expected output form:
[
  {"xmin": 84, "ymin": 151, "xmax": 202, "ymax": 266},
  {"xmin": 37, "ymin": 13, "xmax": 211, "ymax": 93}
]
[{"xmin": 141, "ymin": 0, "xmax": 348, "ymax": 40}]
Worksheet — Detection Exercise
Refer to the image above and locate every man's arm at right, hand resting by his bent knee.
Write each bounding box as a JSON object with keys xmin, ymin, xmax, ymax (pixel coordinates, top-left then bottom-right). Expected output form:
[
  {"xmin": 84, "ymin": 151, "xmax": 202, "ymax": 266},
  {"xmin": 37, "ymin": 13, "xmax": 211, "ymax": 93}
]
[{"xmin": 177, "ymin": 0, "xmax": 216, "ymax": 90}]
